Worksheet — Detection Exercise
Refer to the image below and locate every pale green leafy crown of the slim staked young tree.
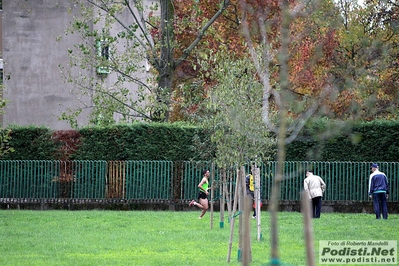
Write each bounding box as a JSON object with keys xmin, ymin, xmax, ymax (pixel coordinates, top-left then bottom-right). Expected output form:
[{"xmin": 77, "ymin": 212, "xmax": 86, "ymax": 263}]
[{"xmin": 198, "ymin": 51, "xmax": 275, "ymax": 168}]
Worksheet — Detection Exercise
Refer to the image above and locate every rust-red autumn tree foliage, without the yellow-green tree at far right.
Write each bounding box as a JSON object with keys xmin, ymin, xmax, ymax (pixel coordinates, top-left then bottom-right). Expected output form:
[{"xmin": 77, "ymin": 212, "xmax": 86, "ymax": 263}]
[{"xmin": 172, "ymin": 0, "xmax": 344, "ymax": 120}]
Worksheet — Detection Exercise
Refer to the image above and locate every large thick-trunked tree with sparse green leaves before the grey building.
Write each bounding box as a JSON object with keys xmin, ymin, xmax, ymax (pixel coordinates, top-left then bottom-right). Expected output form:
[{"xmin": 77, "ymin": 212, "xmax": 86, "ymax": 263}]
[{"xmin": 61, "ymin": 0, "xmax": 233, "ymax": 126}]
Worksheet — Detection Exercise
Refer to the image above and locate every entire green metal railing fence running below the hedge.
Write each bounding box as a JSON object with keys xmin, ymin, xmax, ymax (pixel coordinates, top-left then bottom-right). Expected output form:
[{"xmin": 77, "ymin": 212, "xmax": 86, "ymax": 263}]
[{"xmin": 0, "ymin": 160, "xmax": 399, "ymax": 202}]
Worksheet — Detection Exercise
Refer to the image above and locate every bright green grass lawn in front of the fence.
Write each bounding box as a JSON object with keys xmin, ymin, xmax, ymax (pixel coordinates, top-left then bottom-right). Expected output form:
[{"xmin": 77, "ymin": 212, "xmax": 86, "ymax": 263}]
[{"xmin": 0, "ymin": 210, "xmax": 399, "ymax": 266}]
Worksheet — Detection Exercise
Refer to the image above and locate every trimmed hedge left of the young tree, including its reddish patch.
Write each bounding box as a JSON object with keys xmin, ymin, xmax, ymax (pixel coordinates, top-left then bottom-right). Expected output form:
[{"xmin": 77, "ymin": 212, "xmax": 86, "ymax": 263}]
[{"xmin": 1, "ymin": 123, "xmax": 211, "ymax": 161}]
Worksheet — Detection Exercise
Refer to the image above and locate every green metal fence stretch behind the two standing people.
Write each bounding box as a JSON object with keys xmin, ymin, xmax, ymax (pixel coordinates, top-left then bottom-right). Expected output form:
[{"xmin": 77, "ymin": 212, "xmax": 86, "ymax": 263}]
[{"xmin": 272, "ymin": 162, "xmax": 399, "ymax": 201}]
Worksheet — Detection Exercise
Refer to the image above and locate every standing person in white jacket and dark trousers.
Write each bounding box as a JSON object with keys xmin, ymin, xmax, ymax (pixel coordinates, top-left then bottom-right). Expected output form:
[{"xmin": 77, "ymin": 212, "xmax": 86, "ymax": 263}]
[{"xmin": 303, "ymin": 171, "xmax": 326, "ymax": 218}]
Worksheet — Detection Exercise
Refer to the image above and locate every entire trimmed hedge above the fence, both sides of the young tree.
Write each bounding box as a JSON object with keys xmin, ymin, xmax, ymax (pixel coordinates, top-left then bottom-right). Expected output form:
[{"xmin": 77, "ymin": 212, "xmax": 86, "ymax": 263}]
[{"xmin": 1, "ymin": 120, "xmax": 399, "ymax": 162}]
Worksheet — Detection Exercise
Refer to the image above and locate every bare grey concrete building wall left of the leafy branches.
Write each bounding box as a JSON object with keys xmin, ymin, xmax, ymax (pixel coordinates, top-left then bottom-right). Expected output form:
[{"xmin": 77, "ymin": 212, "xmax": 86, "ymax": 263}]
[{"xmin": 2, "ymin": 0, "xmax": 155, "ymax": 129}]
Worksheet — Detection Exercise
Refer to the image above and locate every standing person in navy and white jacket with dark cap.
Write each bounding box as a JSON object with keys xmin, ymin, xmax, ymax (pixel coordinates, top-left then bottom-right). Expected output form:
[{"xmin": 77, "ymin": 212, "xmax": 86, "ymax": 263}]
[{"xmin": 369, "ymin": 163, "xmax": 389, "ymax": 219}]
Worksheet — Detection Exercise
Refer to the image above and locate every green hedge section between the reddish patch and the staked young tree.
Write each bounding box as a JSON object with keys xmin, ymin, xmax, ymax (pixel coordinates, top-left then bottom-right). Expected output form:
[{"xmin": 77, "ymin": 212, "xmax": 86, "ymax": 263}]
[{"xmin": 71, "ymin": 123, "xmax": 209, "ymax": 161}]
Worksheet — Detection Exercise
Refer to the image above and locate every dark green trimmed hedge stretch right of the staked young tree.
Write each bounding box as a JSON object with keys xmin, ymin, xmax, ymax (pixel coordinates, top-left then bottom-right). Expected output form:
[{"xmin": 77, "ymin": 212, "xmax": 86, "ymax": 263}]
[{"xmin": 287, "ymin": 120, "xmax": 399, "ymax": 162}]
